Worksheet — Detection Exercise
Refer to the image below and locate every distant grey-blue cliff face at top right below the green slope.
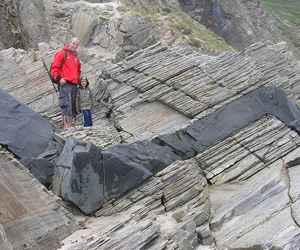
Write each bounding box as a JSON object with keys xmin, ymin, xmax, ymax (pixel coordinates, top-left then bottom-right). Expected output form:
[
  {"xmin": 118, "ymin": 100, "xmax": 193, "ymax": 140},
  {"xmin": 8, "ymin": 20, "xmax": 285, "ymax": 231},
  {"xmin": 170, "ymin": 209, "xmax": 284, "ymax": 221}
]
[{"xmin": 121, "ymin": 0, "xmax": 298, "ymax": 56}]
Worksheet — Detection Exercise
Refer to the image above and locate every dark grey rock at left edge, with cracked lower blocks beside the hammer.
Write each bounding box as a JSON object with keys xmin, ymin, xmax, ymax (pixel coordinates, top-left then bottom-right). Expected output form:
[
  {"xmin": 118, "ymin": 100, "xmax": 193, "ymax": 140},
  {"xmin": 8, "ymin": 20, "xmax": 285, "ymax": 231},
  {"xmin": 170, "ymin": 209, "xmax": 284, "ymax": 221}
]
[{"xmin": 0, "ymin": 89, "xmax": 64, "ymax": 187}]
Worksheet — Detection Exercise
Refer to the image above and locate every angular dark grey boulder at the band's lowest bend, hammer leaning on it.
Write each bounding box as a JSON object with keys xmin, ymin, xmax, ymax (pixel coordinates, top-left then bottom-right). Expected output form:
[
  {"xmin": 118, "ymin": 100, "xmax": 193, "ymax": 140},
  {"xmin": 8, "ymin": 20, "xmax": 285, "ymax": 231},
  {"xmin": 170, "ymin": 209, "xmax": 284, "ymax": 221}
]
[{"xmin": 53, "ymin": 137, "xmax": 180, "ymax": 214}]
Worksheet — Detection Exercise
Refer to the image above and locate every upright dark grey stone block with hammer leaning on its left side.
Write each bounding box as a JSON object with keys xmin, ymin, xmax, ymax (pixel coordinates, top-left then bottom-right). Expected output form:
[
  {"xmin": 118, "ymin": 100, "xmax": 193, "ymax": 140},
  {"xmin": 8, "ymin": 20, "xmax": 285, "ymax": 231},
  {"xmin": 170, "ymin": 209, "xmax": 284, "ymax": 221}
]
[{"xmin": 53, "ymin": 137, "xmax": 104, "ymax": 214}]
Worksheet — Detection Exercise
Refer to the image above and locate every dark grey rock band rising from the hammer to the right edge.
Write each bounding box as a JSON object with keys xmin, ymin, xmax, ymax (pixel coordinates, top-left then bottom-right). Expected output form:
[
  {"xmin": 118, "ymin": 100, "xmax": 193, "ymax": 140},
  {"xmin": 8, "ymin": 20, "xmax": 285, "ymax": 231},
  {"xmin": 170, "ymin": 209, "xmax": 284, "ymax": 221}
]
[{"xmin": 51, "ymin": 83, "xmax": 300, "ymax": 214}]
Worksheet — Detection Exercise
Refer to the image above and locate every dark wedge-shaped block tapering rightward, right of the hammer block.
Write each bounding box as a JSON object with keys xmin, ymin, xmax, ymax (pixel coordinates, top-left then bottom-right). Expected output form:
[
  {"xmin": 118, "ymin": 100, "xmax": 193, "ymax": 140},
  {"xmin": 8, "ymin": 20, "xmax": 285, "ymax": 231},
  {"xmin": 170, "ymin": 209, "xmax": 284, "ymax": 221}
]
[{"xmin": 102, "ymin": 141, "xmax": 181, "ymax": 200}]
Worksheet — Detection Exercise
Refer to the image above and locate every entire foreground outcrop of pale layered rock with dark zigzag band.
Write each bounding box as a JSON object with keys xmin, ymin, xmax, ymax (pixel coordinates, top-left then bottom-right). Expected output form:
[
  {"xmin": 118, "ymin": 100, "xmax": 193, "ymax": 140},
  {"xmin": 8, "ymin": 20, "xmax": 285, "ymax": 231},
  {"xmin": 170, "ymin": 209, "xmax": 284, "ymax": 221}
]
[{"xmin": 0, "ymin": 0, "xmax": 300, "ymax": 250}]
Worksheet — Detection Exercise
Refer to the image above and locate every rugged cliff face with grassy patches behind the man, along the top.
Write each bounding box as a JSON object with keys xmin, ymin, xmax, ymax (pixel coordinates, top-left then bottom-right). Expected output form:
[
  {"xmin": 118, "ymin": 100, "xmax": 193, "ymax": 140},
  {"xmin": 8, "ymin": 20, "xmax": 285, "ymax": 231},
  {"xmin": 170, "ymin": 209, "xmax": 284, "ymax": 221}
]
[{"xmin": 0, "ymin": 0, "xmax": 293, "ymax": 60}]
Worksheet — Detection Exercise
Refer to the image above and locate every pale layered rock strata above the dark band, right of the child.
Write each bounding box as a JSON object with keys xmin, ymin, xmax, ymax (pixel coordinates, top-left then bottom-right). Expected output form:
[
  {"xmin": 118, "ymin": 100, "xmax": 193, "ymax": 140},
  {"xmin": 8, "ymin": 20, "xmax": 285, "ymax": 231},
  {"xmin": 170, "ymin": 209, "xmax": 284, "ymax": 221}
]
[{"xmin": 95, "ymin": 43, "xmax": 300, "ymax": 143}]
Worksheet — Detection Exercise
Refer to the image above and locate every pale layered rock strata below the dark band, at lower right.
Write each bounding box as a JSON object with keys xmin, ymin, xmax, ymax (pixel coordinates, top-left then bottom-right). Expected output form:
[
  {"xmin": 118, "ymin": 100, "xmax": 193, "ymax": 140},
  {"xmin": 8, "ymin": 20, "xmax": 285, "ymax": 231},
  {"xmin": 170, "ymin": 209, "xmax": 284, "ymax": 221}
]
[{"xmin": 59, "ymin": 115, "xmax": 300, "ymax": 249}]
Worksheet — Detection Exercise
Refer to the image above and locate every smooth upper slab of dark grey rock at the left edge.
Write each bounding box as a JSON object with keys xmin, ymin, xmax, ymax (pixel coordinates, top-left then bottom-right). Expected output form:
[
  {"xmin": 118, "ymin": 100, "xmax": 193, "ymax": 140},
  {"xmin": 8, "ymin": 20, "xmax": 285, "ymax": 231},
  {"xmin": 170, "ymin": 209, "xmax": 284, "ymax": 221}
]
[{"xmin": 0, "ymin": 89, "xmax": 59, "ymax": 158}]
